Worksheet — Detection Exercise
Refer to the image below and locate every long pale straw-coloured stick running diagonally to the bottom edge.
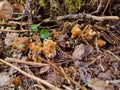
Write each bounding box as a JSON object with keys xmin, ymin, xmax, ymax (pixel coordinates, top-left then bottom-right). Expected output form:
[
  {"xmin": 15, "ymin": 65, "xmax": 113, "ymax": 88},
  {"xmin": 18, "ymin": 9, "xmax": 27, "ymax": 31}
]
[{"xmin": 0, "ymin": 59, "xmax": 62, "ymax": 90}]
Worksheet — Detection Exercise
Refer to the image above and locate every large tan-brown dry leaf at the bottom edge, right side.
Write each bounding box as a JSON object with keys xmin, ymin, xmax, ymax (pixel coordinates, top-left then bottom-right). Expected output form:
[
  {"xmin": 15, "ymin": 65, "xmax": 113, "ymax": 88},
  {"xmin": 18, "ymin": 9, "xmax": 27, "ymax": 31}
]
[{"xmin": 87, "ymin": 78, "xmax": 115, "ymax": 90}]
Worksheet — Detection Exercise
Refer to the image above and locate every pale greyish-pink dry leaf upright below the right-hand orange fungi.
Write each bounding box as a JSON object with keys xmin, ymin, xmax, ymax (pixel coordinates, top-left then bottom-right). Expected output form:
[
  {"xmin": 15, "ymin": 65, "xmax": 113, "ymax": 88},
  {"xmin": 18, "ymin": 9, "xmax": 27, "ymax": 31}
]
[{"xmin": 72, "ymin": 44, "xmax": 85, "ymax": 60}]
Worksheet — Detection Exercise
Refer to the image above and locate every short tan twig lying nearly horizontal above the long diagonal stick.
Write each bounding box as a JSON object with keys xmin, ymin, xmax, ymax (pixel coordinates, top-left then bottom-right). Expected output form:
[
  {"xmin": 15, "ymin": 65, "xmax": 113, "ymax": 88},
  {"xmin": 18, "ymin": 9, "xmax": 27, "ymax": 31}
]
[{"xmin": 5, "ymin": 57, "xmax": 49, "ymax": 67}]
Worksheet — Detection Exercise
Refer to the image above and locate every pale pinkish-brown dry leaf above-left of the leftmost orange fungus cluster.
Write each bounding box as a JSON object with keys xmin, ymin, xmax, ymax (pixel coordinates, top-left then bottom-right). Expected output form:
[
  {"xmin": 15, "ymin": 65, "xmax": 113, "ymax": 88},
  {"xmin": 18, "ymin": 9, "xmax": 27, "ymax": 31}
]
[{"xmin": 5, "ymin": 33, "xmax": 19, "ymax": 46}]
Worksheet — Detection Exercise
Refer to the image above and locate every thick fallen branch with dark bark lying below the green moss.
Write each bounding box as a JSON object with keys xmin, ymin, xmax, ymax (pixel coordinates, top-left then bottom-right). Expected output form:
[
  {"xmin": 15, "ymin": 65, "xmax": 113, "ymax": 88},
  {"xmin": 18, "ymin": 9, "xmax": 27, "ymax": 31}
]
[{"xmin": 42, "ymin": 13, "xmax": 119, "ymax": 23}]
